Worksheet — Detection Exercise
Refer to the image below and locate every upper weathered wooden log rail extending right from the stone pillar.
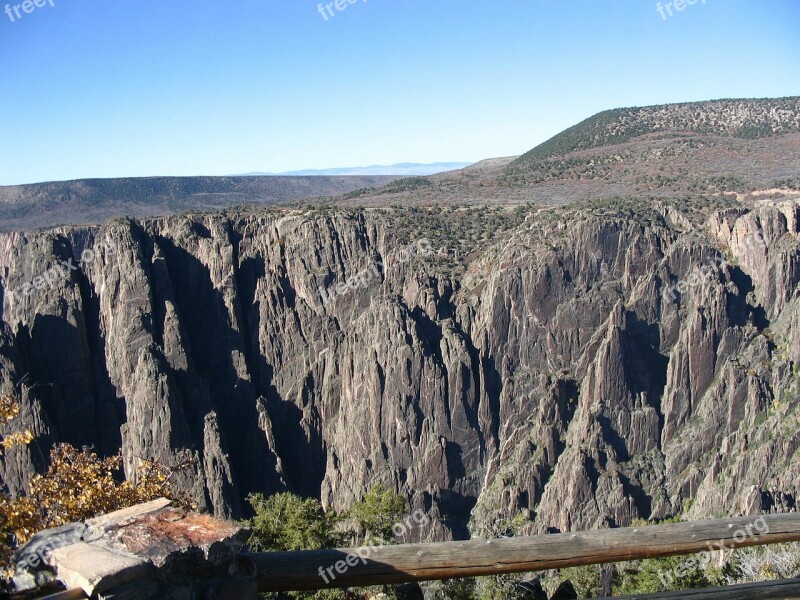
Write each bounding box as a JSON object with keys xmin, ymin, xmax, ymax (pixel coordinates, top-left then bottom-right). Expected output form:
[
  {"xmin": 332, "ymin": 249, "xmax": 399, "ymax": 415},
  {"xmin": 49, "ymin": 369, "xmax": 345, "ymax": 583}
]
[{"xmin": 252, "ymin": 513, "xmax": 800, "ymax": 592}]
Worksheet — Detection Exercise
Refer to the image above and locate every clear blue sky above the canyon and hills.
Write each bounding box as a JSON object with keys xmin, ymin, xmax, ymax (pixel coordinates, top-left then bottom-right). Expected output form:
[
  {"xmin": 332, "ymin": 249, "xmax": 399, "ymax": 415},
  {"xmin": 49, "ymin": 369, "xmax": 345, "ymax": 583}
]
[{"xmin": 0, "ymin": 0, "xmax": 800, "ymax": 185}]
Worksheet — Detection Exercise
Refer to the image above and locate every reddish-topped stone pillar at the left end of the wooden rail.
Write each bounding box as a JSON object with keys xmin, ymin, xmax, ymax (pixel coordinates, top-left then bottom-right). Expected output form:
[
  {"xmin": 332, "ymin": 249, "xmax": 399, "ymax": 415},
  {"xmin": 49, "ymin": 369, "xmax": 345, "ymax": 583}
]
[{"xmin": 13, "ymin": 498, "xmax": 258, "ymax": 600}]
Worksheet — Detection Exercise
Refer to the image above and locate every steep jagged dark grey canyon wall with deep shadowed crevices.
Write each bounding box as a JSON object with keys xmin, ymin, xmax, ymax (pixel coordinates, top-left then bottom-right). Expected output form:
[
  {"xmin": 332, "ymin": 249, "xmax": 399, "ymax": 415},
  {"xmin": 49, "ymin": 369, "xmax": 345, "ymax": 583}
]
[{"xmin": 0, "ymin": 201, "xmax": 800, "ymax": 539}]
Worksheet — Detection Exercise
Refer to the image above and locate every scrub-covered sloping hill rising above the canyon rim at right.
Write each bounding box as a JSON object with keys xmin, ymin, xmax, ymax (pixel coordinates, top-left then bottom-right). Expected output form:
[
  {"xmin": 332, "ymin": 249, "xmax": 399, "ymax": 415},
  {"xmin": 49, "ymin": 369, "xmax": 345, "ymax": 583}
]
[{"xmin": 338, "ymin": 98, "xmax": 800, "ymax": 206}]
